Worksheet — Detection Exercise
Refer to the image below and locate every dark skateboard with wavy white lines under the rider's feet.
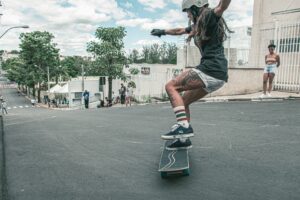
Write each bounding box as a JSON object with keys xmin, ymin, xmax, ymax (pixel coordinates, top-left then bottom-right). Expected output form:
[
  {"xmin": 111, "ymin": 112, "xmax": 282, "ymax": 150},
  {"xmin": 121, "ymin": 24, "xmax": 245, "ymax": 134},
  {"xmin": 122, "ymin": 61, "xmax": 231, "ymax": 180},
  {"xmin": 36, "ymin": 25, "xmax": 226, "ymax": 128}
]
[{"xmin": 158, "ymin": 140, "xmax": 190, "ymax": 178}]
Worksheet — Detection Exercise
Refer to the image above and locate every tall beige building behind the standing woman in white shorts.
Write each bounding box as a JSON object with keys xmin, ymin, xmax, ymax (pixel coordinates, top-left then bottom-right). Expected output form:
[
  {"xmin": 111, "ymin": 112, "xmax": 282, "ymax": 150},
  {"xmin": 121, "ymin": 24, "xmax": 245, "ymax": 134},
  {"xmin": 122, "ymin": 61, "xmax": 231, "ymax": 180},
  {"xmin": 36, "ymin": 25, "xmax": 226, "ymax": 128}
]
[{"xmin": 249, "ymin": 0, "xmax": 300, "ymax": 91}]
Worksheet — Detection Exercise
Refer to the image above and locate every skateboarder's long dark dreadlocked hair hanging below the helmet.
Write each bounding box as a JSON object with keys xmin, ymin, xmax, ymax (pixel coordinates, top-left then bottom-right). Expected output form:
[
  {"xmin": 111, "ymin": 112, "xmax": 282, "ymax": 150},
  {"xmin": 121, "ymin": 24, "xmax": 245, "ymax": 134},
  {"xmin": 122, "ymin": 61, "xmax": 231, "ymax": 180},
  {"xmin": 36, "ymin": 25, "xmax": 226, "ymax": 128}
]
[{"xmin": 195, "ymin": 7, "xmax": 234, "ymax": 42}]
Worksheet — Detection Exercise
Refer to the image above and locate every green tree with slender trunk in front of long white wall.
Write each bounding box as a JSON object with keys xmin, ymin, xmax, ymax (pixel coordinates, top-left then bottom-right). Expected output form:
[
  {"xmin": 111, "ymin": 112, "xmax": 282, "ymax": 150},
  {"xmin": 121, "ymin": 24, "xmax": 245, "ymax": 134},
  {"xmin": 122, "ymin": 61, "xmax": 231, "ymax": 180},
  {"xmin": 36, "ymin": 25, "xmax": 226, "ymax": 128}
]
[{"xmin": 87, "ymin": 26, "xmax": 126, "ymax": 100}]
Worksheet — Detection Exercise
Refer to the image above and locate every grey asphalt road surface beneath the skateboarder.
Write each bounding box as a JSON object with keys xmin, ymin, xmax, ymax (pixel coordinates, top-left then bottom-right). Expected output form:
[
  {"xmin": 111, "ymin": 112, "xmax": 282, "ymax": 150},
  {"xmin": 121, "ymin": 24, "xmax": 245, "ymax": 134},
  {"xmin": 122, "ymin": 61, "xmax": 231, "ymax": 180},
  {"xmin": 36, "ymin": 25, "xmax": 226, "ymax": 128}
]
[{"xmin": 4, "ymin": 86, "xmax": 300, "ymax": 200}]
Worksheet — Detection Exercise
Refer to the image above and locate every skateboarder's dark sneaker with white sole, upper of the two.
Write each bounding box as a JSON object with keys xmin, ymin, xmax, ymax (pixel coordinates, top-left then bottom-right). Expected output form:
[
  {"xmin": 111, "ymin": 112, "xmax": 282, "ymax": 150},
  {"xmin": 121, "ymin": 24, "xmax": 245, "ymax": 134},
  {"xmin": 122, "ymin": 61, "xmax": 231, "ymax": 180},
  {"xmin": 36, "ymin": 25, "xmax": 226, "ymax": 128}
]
[{"xmin": 161, "ymin": 124, "xmax": 194, "ymax": 140}]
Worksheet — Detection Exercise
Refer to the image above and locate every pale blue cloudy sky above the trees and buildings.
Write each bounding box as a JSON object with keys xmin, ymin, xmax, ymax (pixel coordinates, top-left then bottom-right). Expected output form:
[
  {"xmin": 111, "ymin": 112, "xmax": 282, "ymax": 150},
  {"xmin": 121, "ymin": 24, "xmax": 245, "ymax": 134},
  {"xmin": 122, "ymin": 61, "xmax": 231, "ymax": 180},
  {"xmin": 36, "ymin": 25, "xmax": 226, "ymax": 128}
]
[{"xmin": 0, "ymin": 0, "xmax": 254, "ymax": 56}]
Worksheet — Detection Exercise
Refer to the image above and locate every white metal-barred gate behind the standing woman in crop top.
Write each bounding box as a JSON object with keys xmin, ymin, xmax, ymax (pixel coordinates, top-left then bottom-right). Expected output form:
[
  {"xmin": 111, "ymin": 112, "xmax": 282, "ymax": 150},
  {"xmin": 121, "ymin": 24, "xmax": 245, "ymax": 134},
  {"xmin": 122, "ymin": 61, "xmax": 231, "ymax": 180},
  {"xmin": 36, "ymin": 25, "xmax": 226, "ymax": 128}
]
[{"xmin": 252, "ymin": 21, "xmax": 300, "ymax": 91}]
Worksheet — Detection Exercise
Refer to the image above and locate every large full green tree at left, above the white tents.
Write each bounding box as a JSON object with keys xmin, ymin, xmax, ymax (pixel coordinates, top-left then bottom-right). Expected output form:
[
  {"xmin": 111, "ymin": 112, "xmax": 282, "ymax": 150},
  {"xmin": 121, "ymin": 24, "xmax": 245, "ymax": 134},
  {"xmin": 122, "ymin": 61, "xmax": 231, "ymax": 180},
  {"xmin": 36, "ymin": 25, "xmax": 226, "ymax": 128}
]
[{"xmin": 20, "ymin": 31, "xmax": 59, "ymax": 102}]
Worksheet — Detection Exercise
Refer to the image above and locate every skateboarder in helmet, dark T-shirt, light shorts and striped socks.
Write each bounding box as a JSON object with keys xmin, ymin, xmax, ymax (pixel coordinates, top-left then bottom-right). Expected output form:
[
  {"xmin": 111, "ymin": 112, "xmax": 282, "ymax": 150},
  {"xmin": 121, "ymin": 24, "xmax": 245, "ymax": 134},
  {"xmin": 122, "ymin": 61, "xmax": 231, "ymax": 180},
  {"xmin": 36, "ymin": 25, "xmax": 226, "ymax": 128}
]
[{"xmin": 151, "ymin": 0, "xmax": 231, "ymax": 149}]
